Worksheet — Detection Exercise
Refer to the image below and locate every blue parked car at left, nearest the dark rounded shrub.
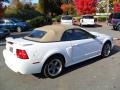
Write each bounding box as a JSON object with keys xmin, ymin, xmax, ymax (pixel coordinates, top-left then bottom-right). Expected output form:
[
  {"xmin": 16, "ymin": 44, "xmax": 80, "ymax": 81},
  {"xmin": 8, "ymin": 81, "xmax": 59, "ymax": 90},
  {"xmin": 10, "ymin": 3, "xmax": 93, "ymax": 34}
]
[{"xmin": 0, "ymin": 18, "xmax": 29, "ymax": 32}]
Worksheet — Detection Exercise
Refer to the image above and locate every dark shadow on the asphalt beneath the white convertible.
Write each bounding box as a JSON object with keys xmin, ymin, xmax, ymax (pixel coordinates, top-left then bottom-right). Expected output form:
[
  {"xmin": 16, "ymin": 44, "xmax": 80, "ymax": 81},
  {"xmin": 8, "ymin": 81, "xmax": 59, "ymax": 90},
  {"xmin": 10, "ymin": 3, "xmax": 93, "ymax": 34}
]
[{"xmin": 33, "ymin": 46, "xmax": 120, "ymax": 79}]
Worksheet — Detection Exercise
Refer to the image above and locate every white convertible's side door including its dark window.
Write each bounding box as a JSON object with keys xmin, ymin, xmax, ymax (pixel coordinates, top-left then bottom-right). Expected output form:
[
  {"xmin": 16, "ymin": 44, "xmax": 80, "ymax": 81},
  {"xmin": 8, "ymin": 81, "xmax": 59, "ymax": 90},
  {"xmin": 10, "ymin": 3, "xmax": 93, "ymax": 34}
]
[{"xmin": 71, "ymin": 29, "xmax": 102, "ymax": 62}]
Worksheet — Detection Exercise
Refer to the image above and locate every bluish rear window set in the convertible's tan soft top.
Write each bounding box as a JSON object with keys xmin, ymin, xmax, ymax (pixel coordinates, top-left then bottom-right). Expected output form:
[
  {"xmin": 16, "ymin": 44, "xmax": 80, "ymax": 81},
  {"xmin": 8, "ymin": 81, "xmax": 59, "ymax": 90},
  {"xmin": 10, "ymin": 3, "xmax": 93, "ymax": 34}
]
[{"xmin": 28, "ymin": 30, "xmax": 46, "ymax": 38}]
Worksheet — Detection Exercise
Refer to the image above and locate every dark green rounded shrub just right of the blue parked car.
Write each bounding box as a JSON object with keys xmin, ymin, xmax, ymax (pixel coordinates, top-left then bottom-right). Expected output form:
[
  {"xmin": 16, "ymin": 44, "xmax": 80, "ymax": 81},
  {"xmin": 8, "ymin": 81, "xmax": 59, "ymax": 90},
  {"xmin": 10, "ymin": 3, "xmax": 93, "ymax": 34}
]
[{"xmin": 27, "ymin": 16, "xmax": 52, "ymax": 28}]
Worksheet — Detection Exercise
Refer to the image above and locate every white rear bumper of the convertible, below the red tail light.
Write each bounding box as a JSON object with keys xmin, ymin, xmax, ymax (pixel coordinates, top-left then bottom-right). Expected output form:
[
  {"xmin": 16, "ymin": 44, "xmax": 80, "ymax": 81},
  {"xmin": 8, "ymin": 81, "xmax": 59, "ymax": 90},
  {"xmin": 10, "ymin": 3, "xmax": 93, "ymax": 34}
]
[{"xmin": 3, "ymin": 49, "xmax": 42, "ymax": 74}]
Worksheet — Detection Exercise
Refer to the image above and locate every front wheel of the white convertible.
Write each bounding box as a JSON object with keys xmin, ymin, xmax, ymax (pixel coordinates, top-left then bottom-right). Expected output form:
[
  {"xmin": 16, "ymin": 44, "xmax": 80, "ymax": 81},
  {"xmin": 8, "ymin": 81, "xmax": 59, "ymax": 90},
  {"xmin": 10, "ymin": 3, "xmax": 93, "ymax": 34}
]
[{"xmin": 101, "ymin": 42, "xmax": 111, "ymax": 58}]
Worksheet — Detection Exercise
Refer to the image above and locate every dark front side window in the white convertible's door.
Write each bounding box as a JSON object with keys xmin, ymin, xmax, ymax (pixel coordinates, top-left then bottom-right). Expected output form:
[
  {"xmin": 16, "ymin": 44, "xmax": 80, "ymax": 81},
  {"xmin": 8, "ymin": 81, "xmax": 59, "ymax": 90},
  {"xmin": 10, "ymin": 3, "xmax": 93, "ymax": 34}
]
[{"xmin": 72, "ymin": 29, "xmax": 92, "ymax": 40}]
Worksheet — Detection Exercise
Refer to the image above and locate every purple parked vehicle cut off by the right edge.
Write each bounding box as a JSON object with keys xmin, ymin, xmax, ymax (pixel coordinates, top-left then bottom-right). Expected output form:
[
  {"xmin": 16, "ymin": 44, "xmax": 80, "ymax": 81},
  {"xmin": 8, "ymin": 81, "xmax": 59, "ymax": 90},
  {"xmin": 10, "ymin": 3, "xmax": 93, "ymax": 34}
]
[{"xmin": 111, "ymin": 13, "xmax": 120, "ymax": 30}]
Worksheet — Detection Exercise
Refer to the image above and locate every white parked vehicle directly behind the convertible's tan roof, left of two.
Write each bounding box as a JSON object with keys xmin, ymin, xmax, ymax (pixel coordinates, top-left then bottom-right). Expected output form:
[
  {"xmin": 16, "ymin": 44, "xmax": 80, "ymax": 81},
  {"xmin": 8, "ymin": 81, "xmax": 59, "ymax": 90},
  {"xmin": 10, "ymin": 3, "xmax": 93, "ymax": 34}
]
[{"xmin": 61, "ymin": 15, "xmax": 73, "ymax": 25}]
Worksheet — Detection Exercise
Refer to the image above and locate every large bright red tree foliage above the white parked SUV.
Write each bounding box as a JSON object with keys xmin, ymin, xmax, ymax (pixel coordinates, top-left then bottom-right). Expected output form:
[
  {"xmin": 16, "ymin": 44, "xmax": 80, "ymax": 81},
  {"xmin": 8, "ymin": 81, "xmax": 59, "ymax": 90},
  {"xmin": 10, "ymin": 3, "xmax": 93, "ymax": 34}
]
[{"xmin": 73, "ymin": 0, "xmax": 97, "ymax": 15}]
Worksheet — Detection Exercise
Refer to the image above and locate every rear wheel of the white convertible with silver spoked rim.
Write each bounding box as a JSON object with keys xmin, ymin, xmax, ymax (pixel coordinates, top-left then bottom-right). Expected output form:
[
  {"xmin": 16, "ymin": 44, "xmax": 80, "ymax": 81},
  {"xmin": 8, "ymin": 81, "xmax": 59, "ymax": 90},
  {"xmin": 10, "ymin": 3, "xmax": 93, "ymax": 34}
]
[{"xmin": 42, "ymin": 56, "xmax": 64, "ymax": 78}]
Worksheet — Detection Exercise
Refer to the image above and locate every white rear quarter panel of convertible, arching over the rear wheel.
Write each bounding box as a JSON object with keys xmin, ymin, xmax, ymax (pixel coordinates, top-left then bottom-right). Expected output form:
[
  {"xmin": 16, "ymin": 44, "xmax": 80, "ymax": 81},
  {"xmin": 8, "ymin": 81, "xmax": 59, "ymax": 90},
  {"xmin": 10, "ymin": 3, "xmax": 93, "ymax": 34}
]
[{"xmin": 23, "ymin": 42, "xmax": 72, "ymax": 65}]
